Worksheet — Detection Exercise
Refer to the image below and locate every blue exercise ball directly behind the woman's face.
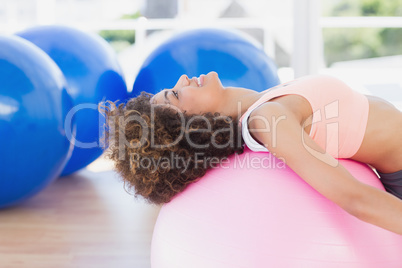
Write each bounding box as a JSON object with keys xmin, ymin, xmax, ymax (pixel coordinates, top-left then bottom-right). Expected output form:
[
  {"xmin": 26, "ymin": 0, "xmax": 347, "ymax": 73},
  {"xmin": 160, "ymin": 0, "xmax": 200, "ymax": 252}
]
[{"xmin": 131, "ymin": 29, "xmax": 279, "ymax": 96}]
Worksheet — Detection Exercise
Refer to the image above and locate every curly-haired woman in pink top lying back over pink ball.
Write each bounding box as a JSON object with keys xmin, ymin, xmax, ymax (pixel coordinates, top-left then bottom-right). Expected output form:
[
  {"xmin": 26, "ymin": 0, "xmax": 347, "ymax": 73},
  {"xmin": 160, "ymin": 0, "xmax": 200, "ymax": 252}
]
[{"xmin": 104, "ymin": 72, "xmax": 402, "ymax": 234}]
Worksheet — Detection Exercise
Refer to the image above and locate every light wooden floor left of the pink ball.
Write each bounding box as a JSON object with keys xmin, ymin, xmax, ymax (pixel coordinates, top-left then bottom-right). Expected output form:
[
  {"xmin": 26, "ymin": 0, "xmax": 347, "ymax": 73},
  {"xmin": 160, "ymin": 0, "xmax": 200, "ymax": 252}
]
[{"xmin": 0, "ymin": 160, "xmax": 159, "ymax": 268}]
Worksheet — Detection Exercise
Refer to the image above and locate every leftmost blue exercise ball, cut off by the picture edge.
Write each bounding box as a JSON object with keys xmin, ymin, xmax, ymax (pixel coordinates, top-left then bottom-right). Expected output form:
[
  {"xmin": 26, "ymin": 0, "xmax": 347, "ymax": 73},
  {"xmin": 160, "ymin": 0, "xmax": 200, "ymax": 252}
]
[{"xmin": 0, "ymin": 36, "xmax": 74, "ymax": 208}]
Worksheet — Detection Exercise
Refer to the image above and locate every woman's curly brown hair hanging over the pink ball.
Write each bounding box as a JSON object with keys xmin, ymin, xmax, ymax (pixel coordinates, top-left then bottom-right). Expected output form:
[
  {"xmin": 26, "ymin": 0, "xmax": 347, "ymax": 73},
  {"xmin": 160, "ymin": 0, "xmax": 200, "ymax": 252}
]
[{"xmin": 100, "ymin": 92, "xmax": 244, "ymax": 204}]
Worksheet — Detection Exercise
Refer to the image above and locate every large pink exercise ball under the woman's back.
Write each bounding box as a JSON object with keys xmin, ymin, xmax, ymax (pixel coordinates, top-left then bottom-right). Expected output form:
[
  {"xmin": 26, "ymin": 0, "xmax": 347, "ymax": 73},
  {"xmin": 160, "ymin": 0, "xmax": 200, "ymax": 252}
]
[{"xmin": 151, "ymin": 150, "xmax": 402, "ymax": 268}]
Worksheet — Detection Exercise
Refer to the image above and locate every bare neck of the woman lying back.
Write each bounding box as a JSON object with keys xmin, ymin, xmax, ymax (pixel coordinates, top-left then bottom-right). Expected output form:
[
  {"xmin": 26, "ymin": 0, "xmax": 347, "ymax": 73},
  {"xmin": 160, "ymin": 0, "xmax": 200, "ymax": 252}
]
[{"xmin": 220, "ymin": 87, "xmax": 265, "ymax": 119}]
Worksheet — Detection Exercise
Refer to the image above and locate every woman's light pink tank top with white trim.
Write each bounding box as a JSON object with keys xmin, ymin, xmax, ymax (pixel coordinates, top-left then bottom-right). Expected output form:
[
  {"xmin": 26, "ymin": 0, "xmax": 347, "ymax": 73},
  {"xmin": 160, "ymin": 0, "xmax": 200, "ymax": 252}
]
[{"xmin": 239, "ymin": 75, "xmax": 369, "ymax": 158}]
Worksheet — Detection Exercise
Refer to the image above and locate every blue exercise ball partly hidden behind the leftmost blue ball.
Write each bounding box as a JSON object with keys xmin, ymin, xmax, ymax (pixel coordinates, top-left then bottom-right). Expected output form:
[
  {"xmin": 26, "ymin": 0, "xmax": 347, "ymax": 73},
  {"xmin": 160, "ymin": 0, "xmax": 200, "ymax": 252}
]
[{"xmin": 17, "ymin": 26, "xmax": 128, "ymax": 176}]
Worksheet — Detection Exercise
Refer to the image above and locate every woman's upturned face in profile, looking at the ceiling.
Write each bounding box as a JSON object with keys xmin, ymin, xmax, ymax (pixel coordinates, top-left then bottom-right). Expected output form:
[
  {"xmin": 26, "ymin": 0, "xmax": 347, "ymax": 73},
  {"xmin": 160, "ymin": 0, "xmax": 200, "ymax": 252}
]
[{"xmin": 151, "ymin": 72, "xmax": 224, "ymax": 114}]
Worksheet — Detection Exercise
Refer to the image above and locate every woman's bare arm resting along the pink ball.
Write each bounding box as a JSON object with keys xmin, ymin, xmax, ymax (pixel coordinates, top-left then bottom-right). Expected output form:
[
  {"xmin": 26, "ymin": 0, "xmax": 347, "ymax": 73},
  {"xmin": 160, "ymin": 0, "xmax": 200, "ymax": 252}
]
[{"xmin": 249, "ymin": 102, "xmax": 402, "ymax": 235}]
